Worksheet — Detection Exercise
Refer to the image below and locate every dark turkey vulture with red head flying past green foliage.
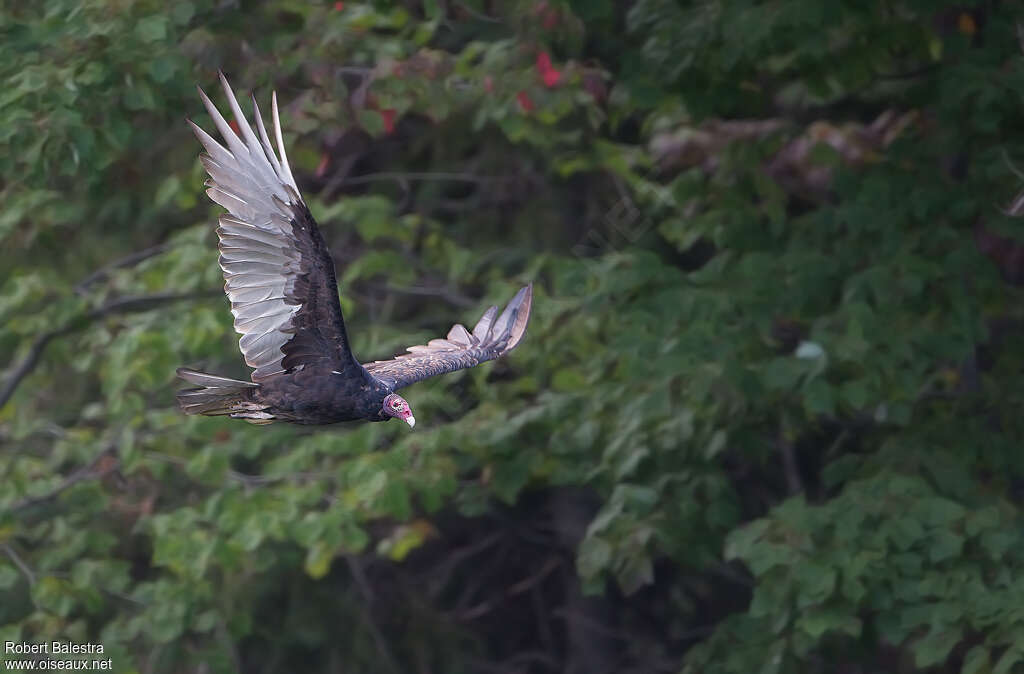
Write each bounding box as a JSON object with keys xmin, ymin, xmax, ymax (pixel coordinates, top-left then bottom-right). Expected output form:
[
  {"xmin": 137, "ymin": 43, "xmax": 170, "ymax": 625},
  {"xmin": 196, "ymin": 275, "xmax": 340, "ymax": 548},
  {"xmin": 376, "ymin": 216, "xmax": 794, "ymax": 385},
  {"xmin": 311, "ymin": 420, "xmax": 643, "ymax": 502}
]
[{"xmin": 178, "ymin": 74, "xmax": 532, "ymax": 427}]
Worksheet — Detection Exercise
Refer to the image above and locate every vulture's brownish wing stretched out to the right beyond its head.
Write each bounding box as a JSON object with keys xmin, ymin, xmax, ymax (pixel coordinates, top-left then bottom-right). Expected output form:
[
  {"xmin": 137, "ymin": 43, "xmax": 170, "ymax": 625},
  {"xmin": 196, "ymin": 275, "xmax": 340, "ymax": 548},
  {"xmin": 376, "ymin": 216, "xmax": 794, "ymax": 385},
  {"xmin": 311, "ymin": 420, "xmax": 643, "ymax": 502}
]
[{"xmin": 362, "ymin": 284, "xmax": 534, "ymax": 389}]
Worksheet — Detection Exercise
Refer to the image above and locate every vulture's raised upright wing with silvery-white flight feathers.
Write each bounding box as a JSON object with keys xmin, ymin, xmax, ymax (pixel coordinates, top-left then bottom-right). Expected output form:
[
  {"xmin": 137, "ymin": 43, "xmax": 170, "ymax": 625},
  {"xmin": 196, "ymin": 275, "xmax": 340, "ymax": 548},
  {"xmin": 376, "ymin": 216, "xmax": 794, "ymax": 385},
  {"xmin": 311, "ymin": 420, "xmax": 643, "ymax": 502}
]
[{"xmin": 188, "ymin": 74, "xmax": 359, "ymax": 382}]
